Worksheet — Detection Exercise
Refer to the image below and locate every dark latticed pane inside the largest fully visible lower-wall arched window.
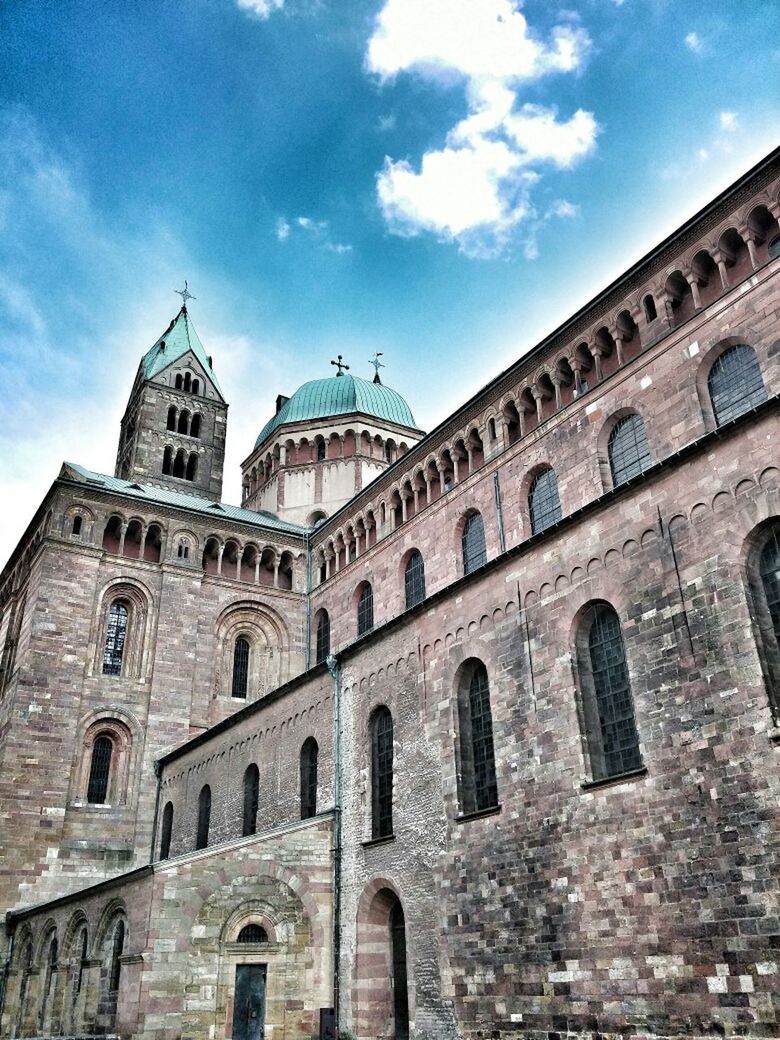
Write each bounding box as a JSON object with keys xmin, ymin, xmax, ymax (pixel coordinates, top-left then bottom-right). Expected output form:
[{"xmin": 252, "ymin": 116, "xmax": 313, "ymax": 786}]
[{"xmin": 589, "ymin": 606, "xmax": 642, "ymax": 776}]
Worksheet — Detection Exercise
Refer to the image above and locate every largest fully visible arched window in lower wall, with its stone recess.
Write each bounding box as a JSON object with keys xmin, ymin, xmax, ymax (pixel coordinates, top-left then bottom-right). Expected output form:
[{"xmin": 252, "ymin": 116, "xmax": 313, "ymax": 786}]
[{"xmin": 578, "ymin": 603, "xmax": 642, "ymax": 779}]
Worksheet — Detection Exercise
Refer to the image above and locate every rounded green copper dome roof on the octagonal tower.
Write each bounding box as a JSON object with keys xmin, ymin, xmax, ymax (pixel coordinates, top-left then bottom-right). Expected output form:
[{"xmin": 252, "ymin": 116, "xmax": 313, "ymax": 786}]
[{"xmin": 255, "ymin": 374, "xmax": 417, "ymax": 447}]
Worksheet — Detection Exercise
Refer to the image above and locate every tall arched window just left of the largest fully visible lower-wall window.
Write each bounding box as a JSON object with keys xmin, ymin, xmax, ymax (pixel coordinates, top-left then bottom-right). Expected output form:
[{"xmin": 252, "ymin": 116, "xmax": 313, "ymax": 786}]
[{"xmin": 458, "ymin": 660, "xmax": 498, "ymax": 814}]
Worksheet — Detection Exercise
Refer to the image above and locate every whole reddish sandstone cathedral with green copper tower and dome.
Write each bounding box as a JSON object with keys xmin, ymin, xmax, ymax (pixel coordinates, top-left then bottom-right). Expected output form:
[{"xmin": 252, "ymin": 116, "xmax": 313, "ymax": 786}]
[{"xmin": 0, "ymin": 150, "xmax": 780, "ymax": 1040}]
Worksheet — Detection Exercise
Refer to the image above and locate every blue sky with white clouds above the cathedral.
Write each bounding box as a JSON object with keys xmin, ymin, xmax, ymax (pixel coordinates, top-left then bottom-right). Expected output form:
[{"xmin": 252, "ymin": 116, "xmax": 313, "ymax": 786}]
[{"xmin": 0, "ymin": 0, "xmax": 780, "ymax": 558}]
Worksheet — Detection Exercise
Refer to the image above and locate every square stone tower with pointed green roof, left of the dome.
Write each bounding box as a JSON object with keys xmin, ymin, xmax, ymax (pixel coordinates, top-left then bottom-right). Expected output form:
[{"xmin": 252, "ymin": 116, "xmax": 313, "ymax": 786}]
[{"xmin": 114, "ymin": 301, "xmax": 228, "ymax": 500}]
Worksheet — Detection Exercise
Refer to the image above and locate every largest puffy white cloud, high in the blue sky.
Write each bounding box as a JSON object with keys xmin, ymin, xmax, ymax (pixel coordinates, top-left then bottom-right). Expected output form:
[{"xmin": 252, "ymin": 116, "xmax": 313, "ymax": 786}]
[{"xmin": 366, "ymin": 0, "xmax": 598, "ymax": 257}]
